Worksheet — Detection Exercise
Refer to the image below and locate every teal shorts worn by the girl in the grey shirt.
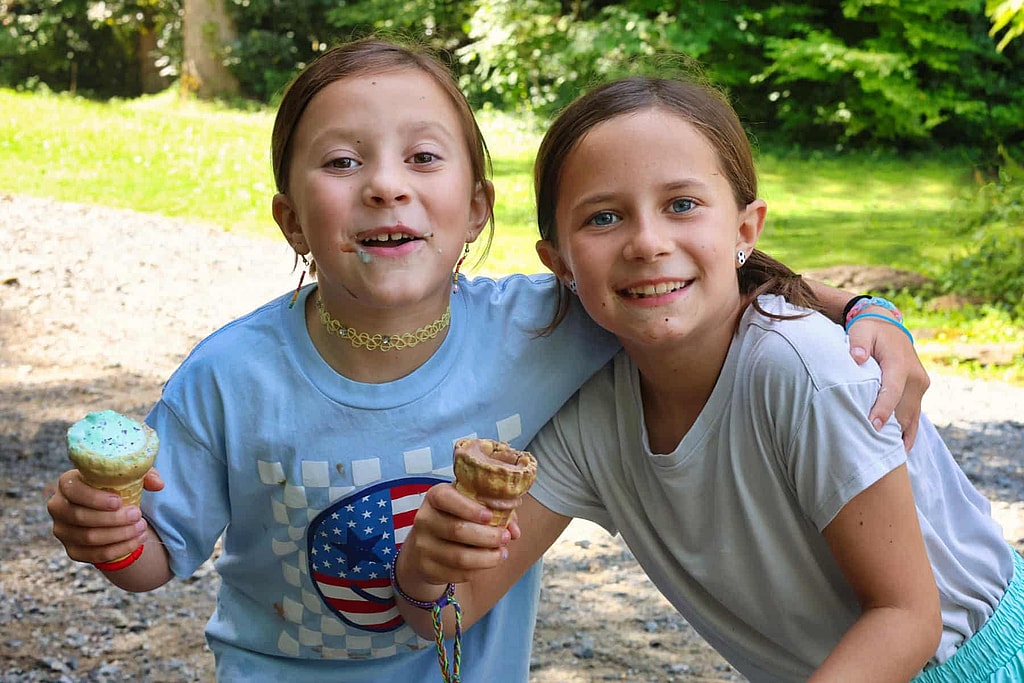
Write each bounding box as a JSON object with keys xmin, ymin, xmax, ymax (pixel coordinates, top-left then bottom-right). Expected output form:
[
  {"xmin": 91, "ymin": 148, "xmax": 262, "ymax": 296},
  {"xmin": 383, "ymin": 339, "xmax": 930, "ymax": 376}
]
[{"xmin": 913, "ymin": 552, "xmax": 1024, "ymax": 683}]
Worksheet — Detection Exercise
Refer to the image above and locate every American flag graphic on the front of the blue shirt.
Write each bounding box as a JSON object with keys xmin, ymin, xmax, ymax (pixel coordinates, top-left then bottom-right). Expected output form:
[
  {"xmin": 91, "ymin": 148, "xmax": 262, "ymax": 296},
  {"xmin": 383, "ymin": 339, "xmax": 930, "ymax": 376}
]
[{"xmin": 306, "ymin": 476, "xmax": 445, "ymax": 633}]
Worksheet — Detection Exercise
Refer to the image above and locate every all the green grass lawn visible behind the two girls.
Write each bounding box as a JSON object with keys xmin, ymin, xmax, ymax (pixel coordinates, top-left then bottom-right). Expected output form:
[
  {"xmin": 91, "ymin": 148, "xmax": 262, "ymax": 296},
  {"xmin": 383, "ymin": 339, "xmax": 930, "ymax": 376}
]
[{"xmin": 0, "ymin": 89, "xmax": 1024, "ymax": 382}]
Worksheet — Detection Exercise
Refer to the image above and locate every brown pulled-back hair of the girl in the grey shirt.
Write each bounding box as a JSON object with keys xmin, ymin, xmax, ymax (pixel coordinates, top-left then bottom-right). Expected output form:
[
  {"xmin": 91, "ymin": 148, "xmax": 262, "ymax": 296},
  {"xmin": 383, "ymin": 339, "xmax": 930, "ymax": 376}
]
[{"xmin": 534, "ymin": 76, "xmax": 820, "ymax": 332}]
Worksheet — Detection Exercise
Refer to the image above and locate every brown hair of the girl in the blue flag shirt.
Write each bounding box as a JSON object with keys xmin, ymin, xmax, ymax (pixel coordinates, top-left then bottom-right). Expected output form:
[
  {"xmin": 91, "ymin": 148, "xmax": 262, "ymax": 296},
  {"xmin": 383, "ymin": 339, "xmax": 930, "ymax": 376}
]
[{"xmin": 270, "ymin": 36, "xmax": 495, "ymax": 253}]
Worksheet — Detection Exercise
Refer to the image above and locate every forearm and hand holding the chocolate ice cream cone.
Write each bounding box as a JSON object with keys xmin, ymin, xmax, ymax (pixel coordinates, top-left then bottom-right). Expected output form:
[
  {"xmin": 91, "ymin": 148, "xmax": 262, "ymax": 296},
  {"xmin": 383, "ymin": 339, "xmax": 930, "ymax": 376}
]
[{"xmin": 395, "ymin": 484, "xmax": 570, "ymax": 639}]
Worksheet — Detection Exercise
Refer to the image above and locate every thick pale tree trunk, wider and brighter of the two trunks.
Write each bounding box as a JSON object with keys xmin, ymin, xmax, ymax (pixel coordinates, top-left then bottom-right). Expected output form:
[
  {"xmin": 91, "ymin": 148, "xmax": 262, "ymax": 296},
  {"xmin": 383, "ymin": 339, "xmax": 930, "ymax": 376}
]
[{"xmin": 181, "ymin": 0, "xmax": 239, "ymax": 99}]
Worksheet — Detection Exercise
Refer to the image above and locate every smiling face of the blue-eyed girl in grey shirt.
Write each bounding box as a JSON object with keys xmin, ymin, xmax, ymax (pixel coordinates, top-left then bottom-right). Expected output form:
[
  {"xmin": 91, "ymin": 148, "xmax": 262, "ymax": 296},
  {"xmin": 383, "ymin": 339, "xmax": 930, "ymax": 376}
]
[{"xmin": 540, "ymin": 109, "xmax": 765, "ymax": 349}]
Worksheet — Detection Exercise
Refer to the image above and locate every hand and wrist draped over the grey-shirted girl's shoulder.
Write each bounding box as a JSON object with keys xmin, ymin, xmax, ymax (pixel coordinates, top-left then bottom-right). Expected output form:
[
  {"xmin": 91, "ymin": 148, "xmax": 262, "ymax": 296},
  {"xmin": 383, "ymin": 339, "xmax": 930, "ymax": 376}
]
[{"xmin": 805, "ymin": 280, "xmax": 931, "ymax": 451}]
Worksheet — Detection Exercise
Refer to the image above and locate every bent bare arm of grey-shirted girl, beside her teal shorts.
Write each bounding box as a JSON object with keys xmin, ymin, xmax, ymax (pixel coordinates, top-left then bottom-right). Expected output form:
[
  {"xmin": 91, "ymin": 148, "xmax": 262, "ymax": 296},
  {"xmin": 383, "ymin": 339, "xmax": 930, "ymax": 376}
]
[{"xmin": 809, "ymin": 464, "xmax": 942, "ymax": 683}]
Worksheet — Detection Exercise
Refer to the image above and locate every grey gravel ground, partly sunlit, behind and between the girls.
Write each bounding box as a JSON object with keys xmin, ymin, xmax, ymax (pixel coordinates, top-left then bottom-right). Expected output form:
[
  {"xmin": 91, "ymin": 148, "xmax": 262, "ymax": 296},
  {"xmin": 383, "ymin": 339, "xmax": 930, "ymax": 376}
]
[{"xmin": 0, "ymin": 196, "xmax": 1024, "ymax": 683}]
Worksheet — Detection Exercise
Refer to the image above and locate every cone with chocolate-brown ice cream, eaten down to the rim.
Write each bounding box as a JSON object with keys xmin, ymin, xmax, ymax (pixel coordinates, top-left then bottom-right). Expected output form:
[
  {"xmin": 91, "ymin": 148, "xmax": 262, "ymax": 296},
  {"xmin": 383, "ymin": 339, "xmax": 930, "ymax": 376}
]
[{"xmin": 454, "ymin": 438, "xmax": 537, "ymax": 526}]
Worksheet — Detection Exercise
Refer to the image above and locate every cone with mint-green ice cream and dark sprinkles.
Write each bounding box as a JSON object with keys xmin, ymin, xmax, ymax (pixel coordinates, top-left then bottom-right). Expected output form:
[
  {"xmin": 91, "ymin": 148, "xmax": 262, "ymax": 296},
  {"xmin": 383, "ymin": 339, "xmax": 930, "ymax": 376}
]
[{"xmin": 68, "ymin": 411, "xmax": 160, "ymax": 505}]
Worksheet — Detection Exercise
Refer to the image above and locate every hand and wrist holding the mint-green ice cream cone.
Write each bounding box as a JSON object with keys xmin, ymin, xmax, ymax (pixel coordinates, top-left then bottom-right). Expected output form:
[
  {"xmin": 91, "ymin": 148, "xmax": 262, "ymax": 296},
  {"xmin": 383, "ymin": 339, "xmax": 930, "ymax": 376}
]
[{"xmin": 46, "ymin": 469, "xmax": 174, "ymax": 593}]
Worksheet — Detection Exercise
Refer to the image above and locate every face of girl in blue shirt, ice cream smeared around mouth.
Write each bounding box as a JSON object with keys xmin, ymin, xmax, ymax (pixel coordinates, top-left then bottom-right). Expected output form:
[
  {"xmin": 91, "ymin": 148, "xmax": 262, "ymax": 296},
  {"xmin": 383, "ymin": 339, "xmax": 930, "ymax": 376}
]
[{"xmin": 273, "ymin": 69, "xmax": 492, "ymax": 314}]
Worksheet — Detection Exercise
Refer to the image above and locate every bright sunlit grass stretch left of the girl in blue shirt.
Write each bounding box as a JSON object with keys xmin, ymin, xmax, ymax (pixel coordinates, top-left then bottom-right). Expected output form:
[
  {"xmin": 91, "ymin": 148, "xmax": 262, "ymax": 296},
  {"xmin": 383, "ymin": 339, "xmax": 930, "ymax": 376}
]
[{"xmin": 0, "ymin": 91, "xmax": 276, "ymax": 234}]
